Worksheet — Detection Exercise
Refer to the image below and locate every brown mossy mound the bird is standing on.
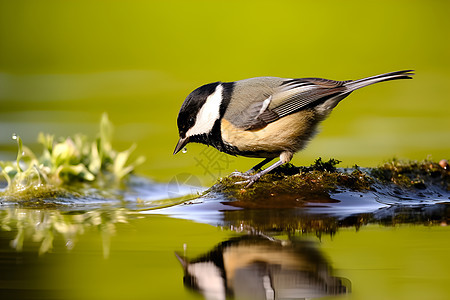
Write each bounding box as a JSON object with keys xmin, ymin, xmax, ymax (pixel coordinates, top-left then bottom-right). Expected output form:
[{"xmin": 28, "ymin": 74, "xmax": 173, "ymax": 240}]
[{"xmin": 210, "ymin": 158, "xmax": 450, "ymax": 207}]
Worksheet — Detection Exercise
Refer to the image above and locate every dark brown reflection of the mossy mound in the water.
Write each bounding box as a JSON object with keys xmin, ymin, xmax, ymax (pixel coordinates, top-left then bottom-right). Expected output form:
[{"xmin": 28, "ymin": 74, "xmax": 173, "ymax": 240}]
[{"xmin": 221, "ymin": 203, "xmax": 450, "ymax": 237}]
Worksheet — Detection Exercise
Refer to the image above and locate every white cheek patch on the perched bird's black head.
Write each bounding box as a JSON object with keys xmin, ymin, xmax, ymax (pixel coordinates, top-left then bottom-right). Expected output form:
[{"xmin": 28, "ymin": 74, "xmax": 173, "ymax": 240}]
[{"xmin": 186, "ymin": 84, "xmax": 223, "ymax": 136}]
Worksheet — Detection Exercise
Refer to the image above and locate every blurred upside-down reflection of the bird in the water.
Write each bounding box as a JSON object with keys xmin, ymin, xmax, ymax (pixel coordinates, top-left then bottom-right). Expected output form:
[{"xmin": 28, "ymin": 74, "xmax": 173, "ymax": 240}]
[{"xmin": 176, "ymin": 236, "xmax": 350, "ymax": 300}]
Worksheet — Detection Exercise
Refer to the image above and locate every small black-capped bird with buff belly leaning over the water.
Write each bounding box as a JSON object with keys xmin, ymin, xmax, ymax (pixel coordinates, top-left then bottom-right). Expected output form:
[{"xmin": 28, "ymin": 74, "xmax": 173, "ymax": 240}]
[{"xmin": 173, "ymin": 70, "xmax": 414, "ymax": 187}]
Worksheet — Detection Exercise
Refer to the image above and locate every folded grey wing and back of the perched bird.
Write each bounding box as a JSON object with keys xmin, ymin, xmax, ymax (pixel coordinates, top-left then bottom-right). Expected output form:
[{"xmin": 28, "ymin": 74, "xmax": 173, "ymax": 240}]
[{"xmin": 225, "ymin": 78, "xmax": 348, "ymax": 130}]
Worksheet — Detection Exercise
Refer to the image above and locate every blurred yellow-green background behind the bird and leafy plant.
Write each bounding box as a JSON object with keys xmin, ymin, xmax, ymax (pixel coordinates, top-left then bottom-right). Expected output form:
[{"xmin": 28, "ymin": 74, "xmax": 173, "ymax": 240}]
[{"xmin": 0, "ymin": 0, "xmax": 450, "ymax": 185}]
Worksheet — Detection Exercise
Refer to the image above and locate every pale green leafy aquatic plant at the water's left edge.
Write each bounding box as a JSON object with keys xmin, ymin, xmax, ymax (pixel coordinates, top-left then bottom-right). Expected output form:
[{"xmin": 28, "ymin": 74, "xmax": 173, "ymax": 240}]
[{"xmin": 0, "ymin": 113, "xmax": 145, "ymax": 202}]
